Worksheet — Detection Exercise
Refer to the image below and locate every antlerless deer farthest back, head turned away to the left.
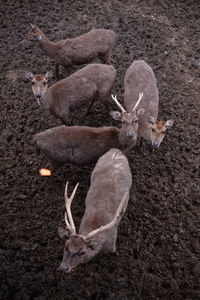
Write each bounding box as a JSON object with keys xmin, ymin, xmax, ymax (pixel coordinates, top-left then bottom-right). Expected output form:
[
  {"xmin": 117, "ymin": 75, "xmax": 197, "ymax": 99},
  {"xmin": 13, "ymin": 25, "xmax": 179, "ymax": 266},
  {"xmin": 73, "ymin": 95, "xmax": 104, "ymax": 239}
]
[{"xmin": 21, "ymin": 24, "xmax": 116, "ymax": 79}]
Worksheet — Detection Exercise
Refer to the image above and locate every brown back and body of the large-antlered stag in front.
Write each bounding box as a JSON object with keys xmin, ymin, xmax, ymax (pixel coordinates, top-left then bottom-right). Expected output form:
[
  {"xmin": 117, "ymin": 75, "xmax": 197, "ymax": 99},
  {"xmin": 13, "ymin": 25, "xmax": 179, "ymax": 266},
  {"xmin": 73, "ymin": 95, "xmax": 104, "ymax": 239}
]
[{"xmin": 79, "ymin": 149, "xmax": 132, "ymax": 239}]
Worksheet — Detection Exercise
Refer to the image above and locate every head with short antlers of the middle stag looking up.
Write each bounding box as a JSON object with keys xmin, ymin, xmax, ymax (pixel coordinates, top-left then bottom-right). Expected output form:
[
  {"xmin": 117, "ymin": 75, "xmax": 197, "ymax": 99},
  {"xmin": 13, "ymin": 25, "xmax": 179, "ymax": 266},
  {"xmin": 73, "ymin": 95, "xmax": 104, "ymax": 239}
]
[{"xmin": 111, "ymin": 93, "xmax": 145, "ymax": 144}]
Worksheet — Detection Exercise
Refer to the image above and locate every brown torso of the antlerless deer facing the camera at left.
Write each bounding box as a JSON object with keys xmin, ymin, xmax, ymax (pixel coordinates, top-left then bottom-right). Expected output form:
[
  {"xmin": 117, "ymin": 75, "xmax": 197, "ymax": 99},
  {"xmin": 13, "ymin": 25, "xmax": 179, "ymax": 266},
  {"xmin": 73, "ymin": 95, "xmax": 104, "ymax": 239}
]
[{"xmin": 45, "ymin": 64, "xmax": 116, "ymax": 115}]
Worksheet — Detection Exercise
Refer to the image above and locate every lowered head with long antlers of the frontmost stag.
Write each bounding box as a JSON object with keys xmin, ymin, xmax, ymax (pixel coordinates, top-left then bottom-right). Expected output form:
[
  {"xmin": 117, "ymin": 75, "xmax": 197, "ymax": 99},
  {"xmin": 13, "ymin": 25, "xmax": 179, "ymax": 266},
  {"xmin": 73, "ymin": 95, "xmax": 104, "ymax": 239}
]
[{"xmin": 58, "ymin": 182, "xmax": 127, "ymax": 273}]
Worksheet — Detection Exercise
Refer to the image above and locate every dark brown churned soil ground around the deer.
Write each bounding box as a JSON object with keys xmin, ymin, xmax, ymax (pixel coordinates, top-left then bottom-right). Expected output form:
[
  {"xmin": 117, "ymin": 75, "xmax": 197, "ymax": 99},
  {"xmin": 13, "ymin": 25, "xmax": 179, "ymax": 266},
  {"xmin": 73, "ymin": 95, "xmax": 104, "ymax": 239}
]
[{"xmin": 0, "ymin": 0, "xmax": 200, "ymax": 300}]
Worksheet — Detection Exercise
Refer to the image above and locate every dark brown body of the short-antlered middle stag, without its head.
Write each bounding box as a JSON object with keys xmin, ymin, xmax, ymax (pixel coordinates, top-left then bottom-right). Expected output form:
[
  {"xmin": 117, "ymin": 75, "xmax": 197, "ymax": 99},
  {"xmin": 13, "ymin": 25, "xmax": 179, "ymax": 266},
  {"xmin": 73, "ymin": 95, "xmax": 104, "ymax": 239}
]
[{"xmin": 34, "ymin": 125, "xmax": 119, "ymax": 165}]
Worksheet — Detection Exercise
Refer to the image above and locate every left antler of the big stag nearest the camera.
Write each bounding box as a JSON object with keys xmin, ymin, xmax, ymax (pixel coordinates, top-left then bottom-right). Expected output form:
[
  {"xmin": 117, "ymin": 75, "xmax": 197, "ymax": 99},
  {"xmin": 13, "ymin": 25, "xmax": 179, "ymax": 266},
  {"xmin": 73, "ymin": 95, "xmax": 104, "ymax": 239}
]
[{"xmin": 65, "ymin": 181, "xmax": 79, "ymax": 234}]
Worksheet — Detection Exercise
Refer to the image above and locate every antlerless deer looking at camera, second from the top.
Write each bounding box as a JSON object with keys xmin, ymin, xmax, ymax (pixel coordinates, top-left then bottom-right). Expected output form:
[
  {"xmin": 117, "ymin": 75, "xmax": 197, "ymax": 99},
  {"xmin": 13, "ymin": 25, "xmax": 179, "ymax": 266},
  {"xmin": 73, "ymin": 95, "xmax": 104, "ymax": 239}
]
[{"xmin": 25, "ymin": 64, "xmax": 116, "ymax": 124}]
